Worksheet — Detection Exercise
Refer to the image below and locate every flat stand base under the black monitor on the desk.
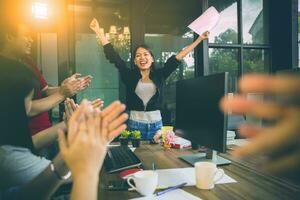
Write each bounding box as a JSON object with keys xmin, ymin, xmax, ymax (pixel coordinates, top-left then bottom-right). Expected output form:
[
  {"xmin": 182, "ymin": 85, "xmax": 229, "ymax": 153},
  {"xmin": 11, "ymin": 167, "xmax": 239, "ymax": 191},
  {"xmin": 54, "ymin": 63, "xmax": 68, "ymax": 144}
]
[{"xmin": 179, "ymin": 149, "xmax": 231, "ymax": 166}]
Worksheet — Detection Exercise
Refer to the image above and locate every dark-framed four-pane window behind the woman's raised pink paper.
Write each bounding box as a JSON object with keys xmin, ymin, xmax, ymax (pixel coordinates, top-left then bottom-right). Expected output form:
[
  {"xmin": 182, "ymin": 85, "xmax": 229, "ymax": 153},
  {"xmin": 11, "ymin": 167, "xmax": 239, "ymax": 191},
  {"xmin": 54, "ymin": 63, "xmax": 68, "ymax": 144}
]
[{"xmin": 209, "ymin": 0, "xmax": 270, "ymax": 92}]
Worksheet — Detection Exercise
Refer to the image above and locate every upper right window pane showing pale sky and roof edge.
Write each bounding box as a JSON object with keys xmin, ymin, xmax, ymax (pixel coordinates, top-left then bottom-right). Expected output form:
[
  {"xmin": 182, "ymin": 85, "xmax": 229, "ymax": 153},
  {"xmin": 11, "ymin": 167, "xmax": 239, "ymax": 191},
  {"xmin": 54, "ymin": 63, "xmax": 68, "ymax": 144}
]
[{"xmin": 242, "ymin": 0, "xmax": 269, "ymax": 44}]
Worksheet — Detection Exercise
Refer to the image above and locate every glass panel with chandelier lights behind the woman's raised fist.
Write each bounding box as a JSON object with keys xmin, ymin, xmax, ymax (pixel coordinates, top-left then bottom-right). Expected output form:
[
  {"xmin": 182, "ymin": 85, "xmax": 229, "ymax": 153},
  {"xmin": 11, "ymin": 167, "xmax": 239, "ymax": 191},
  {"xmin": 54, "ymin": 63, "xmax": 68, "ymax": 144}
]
[{"xmin": 74, "ymin": 2, "xmax": 130, "ymax": 106}]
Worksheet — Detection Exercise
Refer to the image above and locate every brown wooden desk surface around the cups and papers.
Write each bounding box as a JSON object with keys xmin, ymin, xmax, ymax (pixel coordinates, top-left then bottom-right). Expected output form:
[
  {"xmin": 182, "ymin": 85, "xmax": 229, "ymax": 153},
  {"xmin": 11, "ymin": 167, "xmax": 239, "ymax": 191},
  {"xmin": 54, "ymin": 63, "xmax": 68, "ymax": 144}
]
[{"xmin": 99, "ymin": 145, "xmax": 300, "ymax": 200}]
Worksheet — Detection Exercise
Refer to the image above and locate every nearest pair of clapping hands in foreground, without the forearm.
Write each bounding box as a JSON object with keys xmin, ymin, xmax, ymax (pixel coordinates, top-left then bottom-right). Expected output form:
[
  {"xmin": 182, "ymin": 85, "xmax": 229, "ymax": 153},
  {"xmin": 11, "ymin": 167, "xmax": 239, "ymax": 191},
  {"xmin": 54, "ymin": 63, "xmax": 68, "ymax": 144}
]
[{"xmin": 59, "ymin": 100, "xmax": 128, "ymax": 177}]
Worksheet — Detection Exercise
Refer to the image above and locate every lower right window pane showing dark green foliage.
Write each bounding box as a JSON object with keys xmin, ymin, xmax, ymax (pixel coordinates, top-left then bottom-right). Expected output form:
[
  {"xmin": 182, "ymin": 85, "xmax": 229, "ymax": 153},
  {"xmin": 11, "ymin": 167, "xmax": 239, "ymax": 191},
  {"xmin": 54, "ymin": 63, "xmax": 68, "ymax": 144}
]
[{"xmin": 243, "ymin": 49, "xmax": 270, "ymax": 74}]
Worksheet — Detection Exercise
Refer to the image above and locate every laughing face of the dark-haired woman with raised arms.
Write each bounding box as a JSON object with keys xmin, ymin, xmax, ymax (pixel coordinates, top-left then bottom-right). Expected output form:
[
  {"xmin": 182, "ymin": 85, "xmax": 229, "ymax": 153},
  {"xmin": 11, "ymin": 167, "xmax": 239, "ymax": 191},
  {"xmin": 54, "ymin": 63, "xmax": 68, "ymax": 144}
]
[{"xmin": 134, "ymin": 47, "xmax": 154, "ymax": 70}]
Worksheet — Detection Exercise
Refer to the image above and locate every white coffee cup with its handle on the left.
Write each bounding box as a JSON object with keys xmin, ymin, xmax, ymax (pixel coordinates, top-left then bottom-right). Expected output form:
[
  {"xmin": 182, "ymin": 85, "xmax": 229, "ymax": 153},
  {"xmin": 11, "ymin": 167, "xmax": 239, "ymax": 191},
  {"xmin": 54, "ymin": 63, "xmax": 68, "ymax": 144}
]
[{"xmin": 127, "ymin": 170, "xmax": 158, "ymax": 196}]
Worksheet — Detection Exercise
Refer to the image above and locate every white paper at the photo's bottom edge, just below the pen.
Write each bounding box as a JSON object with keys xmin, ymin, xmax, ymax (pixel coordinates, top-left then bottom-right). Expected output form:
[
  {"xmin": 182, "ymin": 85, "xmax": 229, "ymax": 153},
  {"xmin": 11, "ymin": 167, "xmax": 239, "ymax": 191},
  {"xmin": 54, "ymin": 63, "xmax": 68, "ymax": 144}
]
[{"xmin": 132, "ymin": 189, "xmax": 201, "ymax": 200}]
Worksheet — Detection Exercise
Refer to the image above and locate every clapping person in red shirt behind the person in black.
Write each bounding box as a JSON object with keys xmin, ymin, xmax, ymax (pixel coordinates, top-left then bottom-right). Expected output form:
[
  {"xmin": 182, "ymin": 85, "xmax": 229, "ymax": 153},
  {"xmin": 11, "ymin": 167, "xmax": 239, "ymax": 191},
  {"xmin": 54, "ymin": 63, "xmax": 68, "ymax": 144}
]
[{"xmin": 0, "ymin": 12, "xmax": 92, "ymax": 141}]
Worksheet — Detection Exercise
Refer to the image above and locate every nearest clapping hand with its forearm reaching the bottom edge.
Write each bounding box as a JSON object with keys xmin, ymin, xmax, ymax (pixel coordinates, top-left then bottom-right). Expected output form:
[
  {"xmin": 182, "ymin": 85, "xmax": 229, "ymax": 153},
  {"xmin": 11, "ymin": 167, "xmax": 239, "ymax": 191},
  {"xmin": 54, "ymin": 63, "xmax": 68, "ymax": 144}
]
[{"xmin": 59, "ymin": 102, "xmax": 126, "ymax": 200}]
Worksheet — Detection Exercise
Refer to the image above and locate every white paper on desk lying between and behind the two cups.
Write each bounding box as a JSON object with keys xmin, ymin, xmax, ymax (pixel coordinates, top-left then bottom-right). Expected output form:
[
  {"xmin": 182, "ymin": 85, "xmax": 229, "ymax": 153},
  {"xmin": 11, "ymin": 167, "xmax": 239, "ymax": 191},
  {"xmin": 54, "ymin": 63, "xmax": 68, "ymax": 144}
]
[{"xmin": 156, "ymin": 167, "xmax": 237, "ymax": 188}]
